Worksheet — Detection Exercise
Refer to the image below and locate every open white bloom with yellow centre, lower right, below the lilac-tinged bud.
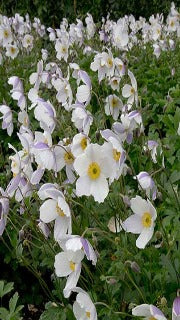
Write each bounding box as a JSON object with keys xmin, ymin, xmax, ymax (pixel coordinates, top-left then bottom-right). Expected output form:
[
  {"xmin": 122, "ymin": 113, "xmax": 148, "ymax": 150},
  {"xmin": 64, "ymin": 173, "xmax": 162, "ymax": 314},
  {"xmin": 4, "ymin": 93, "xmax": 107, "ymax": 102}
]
[{"xmin": 123, "ymin": 196, "xmax": 157, "ymax": 249}]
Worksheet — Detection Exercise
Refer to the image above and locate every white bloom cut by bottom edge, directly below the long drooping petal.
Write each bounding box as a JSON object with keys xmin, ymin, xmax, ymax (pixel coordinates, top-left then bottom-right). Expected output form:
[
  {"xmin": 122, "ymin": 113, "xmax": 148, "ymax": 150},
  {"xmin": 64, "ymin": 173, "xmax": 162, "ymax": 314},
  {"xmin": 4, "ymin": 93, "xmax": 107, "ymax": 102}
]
[{"xmin": 73, "ymin": 288, "xmax": 97, "ymax": 320}]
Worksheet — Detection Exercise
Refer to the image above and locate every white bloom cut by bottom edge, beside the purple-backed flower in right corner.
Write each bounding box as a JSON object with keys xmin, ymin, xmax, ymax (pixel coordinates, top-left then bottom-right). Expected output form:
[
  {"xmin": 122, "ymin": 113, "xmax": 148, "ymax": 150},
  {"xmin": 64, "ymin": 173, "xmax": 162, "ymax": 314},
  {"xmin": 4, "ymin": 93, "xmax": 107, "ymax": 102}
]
[{"xmin": 132, "ymin": 304, "xmax": 167, "ymax": 320}]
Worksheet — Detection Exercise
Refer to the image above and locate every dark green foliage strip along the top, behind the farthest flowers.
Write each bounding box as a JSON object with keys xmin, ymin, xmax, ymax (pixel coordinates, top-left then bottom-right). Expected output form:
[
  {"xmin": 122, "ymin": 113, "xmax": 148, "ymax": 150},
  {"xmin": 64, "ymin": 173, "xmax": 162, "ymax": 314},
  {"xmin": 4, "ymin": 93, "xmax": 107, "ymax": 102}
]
[{"xmin": 0, "ymin": 0, "xmax": 179, "ymax": 27}]
